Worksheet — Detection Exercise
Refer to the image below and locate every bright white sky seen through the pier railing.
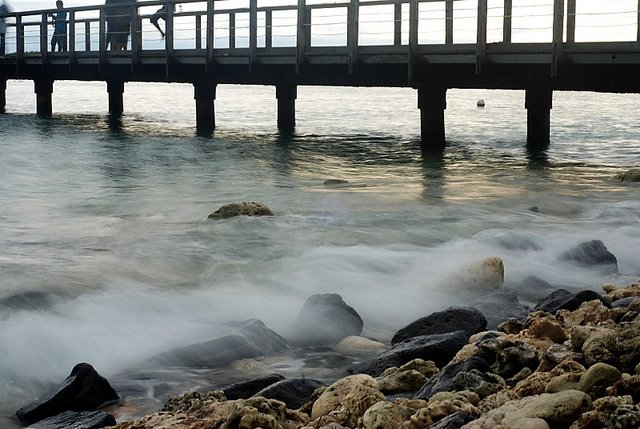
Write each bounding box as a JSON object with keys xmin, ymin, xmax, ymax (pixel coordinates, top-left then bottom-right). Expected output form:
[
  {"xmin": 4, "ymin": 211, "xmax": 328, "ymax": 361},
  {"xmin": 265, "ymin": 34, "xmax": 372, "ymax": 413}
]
[{"xmin": 9, "ymin": 0, "xmax": 638, "ymax": 46}]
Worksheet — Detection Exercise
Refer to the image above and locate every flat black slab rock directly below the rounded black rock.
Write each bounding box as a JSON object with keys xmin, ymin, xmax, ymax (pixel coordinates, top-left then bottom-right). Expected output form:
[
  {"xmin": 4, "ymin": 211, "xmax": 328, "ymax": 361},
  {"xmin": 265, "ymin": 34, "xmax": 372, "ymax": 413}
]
[{"xmin": 348, "ymin": 331, "xmax": 469, "ymax": 377}]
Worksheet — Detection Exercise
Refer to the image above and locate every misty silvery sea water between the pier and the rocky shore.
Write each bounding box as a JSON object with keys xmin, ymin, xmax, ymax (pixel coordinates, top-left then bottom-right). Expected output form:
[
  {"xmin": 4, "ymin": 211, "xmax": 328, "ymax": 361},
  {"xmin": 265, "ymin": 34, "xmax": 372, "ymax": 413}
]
[{"xmin": 0, "ymin": 81, "xmax": 640, "ymax": 427}]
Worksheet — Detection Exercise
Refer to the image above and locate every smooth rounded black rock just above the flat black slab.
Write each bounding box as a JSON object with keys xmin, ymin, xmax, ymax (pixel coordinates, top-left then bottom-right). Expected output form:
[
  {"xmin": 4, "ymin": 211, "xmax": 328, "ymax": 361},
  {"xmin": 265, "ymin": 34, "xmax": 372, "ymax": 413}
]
[{"xmin": 391, "ymin": 307, "xmax": 487, "ymax": 345}]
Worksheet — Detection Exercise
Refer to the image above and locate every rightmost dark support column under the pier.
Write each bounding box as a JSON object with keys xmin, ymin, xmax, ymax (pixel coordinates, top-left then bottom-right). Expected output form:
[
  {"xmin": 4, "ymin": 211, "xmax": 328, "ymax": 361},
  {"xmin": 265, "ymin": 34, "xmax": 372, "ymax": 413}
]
[{"xmin": 524, "ymin": 88, "xmax": 553, "ymax": 152}]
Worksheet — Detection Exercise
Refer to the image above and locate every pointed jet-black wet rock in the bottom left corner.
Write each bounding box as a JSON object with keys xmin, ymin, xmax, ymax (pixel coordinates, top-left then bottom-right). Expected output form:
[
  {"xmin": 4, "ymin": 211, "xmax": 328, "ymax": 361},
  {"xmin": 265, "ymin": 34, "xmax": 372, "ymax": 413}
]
[{"xmin": 16, "ymin": 363, "xmax": 120, "ymax": 424}]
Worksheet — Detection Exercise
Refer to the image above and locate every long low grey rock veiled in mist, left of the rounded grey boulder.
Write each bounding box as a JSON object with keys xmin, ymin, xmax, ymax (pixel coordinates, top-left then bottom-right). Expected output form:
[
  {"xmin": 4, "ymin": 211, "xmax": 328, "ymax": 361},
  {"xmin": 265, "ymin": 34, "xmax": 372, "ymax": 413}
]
[{"xmin": 152, "ymin": 319, "xmax": 288, "ymax": 368}]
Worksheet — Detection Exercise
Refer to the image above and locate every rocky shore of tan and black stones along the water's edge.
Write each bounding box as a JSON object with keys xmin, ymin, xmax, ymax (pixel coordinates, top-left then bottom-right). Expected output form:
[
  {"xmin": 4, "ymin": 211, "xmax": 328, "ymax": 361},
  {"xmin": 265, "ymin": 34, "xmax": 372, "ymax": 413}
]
[{"xmin": 17, "ymin": 231, "xmax": 640, "ymax": 429}]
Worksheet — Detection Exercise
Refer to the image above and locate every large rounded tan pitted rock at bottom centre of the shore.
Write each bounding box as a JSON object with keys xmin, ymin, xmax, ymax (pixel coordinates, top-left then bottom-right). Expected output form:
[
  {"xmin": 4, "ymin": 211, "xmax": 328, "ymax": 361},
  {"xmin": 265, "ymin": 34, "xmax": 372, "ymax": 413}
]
[{"xmin": 311, "ymin": 374, "xmax": 384, "ymax": 428}]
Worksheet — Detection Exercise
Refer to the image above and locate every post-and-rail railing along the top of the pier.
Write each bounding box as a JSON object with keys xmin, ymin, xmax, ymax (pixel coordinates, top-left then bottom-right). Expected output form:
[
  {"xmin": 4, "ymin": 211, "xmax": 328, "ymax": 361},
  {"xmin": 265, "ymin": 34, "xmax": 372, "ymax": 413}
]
[{"xmin": 2, "ymin": 0, "xmax": 640, "ymax": 73}]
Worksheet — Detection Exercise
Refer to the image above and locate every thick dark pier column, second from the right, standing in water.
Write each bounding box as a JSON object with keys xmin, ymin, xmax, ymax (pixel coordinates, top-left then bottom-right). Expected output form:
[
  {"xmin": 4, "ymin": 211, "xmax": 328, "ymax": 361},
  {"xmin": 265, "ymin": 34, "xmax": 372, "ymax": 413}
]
[{"xmin": 418, "ymin": 86, "xmax": 447, "ymax": 150}]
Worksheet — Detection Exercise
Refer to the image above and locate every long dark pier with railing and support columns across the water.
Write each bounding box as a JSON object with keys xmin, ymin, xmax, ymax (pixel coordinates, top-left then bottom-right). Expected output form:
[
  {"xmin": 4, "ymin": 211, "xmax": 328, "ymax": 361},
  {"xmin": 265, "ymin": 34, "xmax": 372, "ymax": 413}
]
[{"xmin": 0, "ymin": 0, "xmax": 640, "ymax": 150}]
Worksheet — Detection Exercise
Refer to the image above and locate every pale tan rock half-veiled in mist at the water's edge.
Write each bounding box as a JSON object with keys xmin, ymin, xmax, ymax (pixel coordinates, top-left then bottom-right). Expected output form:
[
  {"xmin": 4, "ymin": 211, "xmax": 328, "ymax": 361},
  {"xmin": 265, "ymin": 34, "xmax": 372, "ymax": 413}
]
[{"xmin": 440, "ymin": 257, "xmax": 504, "ymax": 293}]
